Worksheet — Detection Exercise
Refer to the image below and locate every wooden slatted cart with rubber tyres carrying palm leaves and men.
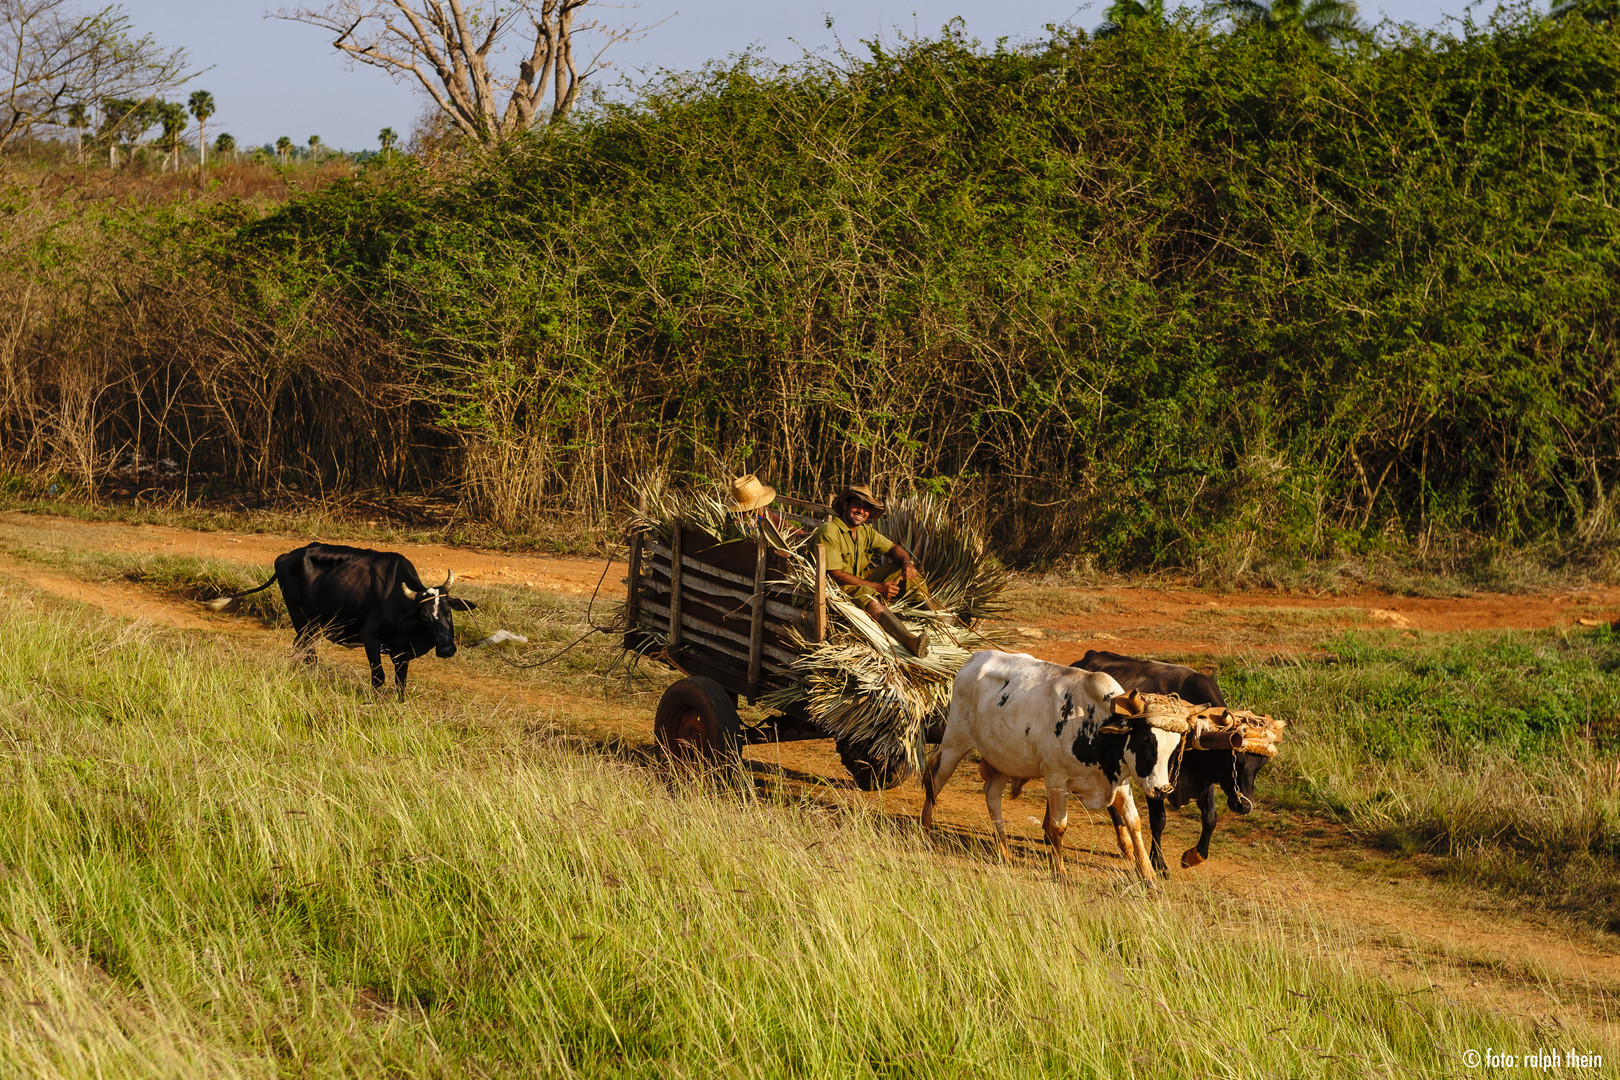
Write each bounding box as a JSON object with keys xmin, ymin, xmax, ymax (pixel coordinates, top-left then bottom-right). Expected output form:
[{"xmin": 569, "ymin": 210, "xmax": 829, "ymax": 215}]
[{"xmin": 624, "ymin": 497, "xmax": 912, "ymax": 790}]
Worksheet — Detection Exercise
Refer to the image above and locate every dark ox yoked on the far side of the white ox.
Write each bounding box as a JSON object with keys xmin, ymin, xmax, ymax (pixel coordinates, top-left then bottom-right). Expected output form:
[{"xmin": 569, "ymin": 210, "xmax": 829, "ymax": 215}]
[{"xmin": 1072, "ymin": 649, "xmax": 1265, "ymax": 874}]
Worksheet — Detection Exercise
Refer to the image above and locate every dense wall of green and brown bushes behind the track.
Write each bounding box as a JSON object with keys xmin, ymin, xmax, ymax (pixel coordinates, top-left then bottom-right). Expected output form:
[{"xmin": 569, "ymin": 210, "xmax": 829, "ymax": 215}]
[{"xmin": 0, "ymin": 10, "xmax": 1620, "ymax": 576}]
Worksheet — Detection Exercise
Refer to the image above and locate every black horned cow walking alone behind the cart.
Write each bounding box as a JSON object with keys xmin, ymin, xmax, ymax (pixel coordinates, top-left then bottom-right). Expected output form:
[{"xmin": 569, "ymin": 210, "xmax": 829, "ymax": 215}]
[{"xmin": 207, "ymin": 544, "xmax": 478, "ymax": 701}]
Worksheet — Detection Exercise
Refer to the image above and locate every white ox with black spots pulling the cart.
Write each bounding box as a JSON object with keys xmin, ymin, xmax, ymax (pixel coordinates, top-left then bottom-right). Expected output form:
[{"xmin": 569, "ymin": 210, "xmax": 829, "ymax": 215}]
[{"xmin": 922, "ymin": 651, "xmax": 1181, "ymax": 887}]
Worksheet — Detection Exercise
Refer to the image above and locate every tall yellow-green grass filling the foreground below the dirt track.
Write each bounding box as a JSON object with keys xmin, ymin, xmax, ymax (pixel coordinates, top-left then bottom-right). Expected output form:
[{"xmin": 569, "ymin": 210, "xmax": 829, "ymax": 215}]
[{"xmin": 0, "ymin": 591, "xmax": 1601, "ymax": 1077}]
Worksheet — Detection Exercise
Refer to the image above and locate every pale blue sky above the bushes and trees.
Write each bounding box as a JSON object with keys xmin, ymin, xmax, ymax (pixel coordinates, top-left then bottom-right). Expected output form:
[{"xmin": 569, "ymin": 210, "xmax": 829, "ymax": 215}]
[{"xmin": 122, "ymin": 0, "xmax": 1494, "ymax": 151}]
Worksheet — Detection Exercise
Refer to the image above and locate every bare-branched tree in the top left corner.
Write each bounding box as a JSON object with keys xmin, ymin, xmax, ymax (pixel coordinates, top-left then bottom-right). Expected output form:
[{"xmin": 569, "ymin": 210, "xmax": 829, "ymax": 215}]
[{"xmin": 0, "ymin": 0, "xmax": 186, "ymax": 149}]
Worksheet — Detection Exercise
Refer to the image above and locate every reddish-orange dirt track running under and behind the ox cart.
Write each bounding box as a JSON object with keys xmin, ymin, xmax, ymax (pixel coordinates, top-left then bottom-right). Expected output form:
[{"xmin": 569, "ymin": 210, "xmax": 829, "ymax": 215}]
[{"xmin": 0, "ymin": 513, "xmax": 1620, "ymax": 1038}]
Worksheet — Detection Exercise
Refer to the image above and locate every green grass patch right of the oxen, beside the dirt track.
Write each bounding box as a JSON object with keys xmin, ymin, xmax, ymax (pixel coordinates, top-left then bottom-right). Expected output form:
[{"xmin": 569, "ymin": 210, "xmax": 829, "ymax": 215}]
[{"xmin": 1221, "ymin": 627, "xmax": 1620, "ymax": 933}]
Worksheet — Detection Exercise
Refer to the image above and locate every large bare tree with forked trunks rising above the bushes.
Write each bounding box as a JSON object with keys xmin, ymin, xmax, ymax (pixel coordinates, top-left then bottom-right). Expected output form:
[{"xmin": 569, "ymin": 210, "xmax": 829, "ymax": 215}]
[{"xmin": 277, "ymin": 0, "xmax": 646, "ymax": 146}]
